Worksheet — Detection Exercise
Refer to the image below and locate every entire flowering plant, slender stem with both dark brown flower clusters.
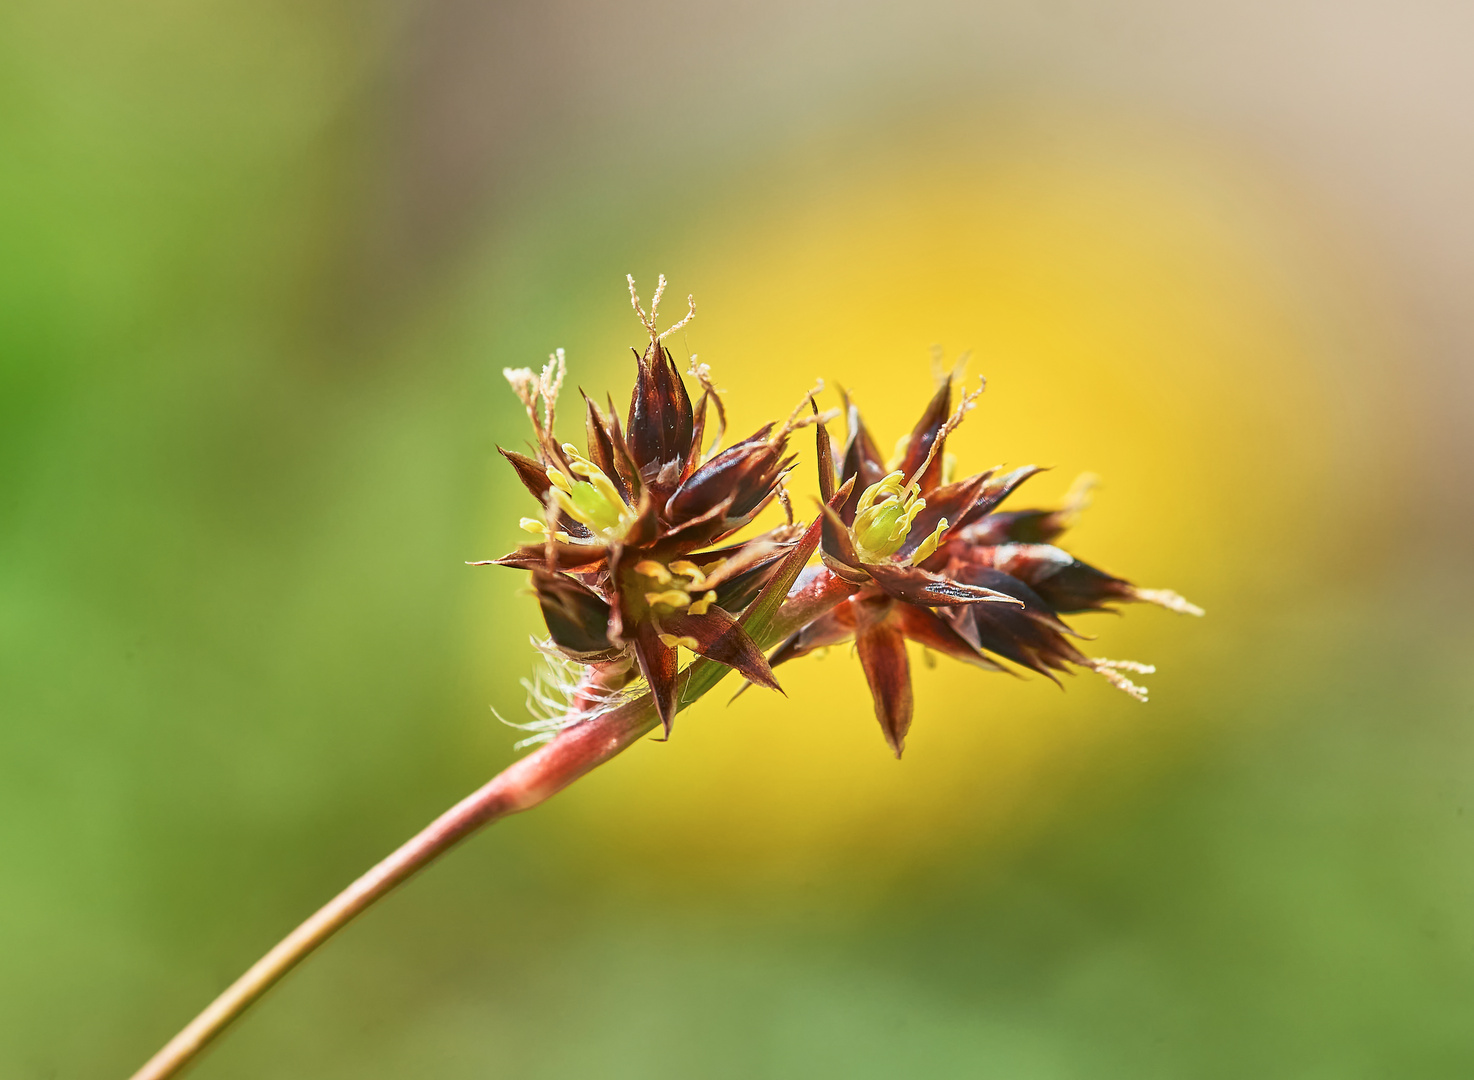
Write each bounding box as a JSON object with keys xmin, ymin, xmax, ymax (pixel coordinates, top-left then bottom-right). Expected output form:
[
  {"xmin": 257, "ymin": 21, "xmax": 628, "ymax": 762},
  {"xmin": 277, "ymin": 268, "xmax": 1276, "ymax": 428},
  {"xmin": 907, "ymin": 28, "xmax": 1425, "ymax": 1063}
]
[{"xmin": 134, "ymin": 277, "xmax": 1203, "ymax": 1080}]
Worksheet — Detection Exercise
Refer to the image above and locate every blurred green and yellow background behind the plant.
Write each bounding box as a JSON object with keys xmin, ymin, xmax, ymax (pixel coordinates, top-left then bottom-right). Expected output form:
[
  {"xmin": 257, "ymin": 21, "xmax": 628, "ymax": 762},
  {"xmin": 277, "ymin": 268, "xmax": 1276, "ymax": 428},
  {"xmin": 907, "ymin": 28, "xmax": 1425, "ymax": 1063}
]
[{"xmin": 0, "ymin": 0, "xmax": 1474, "ymax": 1080}]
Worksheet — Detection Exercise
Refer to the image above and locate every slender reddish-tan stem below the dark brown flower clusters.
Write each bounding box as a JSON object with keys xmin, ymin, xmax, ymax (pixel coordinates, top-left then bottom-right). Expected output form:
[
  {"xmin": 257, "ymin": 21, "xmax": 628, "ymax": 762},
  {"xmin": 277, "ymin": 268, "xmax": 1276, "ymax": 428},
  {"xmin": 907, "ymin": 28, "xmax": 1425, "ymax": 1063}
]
[{"xmin": 133, "ymin": 694, "xmax": 656, "ymax": 1080}]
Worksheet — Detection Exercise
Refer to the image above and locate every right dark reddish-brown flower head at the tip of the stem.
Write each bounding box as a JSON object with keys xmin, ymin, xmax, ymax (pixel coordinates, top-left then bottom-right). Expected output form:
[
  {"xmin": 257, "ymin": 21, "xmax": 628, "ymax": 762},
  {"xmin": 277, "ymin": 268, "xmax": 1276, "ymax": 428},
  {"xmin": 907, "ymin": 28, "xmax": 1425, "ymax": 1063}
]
[{"xmin": 768, "ymin": 366, "xmax": 1201, "ymax": 757}]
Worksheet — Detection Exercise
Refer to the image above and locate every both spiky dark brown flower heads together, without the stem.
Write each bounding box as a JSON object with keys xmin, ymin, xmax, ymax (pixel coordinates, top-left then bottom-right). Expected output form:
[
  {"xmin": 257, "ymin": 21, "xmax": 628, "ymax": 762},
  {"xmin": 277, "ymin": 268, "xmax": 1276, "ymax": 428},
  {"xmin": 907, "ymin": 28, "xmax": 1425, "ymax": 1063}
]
[{"xmin": 477, "ymin": 277, "xmax": 1201, "ymax": 756}]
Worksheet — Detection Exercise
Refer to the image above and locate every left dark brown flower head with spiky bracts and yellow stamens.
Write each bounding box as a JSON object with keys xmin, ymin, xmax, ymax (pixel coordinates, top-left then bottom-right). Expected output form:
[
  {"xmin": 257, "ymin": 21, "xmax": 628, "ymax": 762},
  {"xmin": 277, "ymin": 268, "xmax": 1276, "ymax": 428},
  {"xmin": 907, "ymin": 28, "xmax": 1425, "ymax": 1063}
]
[{"xmin": 474, "ymin": 276, "xmax": 812, "ymax": 729}]
